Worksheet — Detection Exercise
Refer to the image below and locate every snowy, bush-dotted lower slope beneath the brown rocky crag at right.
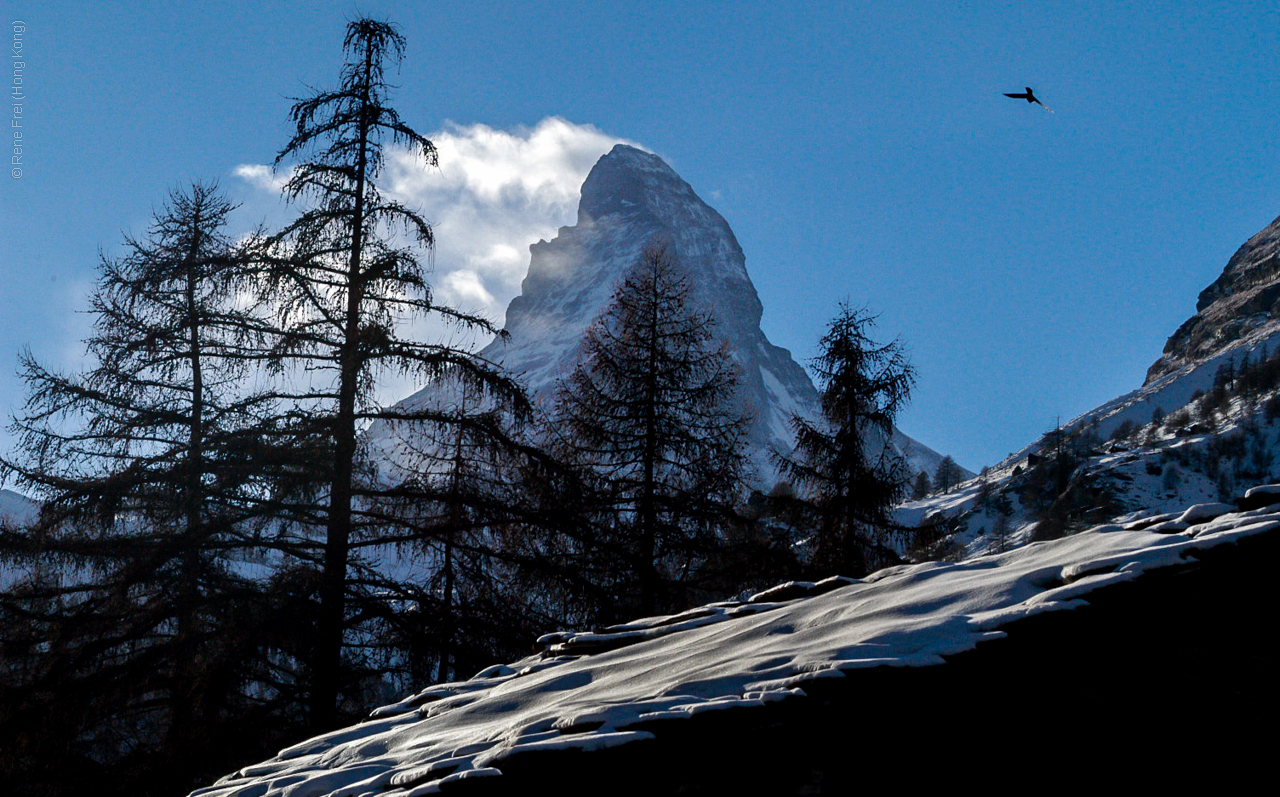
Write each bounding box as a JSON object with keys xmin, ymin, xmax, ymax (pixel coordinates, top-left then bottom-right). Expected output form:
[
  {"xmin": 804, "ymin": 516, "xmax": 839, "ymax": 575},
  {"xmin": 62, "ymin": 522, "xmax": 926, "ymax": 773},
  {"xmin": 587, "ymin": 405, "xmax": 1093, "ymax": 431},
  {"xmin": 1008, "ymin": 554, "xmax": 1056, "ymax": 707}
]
[{"xmin": 895, "ymin": 350, "xmax": 1280, "ymax": 558}]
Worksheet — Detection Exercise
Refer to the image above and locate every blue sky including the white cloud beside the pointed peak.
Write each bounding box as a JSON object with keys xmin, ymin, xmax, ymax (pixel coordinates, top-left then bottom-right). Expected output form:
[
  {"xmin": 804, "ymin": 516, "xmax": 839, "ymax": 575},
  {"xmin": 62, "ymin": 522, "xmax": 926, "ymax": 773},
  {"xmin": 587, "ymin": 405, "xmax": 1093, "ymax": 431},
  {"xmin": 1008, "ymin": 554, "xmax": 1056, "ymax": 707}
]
[{"xmin": 0, "ymin": 0, "xmax": 1280, "ymax": 468}]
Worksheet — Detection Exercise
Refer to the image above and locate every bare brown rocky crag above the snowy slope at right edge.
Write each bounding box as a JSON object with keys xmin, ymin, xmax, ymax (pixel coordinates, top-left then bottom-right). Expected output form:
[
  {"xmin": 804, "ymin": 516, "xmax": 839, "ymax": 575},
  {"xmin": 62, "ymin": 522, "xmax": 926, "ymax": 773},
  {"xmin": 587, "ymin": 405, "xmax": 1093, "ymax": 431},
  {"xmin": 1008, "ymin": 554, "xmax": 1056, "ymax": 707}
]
[{"xmin": 1146, "ymin": 213, "xmax": 1280, "ymax": 385}]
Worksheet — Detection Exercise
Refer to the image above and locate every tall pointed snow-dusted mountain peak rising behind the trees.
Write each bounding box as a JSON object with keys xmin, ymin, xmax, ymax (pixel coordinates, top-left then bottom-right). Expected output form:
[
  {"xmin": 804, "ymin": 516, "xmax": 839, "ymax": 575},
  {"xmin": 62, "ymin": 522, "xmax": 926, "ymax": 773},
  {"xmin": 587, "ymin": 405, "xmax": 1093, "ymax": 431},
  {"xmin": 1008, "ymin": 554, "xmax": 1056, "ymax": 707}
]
[{"xmin": 384, "ymin": 145, "xmax": 957, "ymax": 489}]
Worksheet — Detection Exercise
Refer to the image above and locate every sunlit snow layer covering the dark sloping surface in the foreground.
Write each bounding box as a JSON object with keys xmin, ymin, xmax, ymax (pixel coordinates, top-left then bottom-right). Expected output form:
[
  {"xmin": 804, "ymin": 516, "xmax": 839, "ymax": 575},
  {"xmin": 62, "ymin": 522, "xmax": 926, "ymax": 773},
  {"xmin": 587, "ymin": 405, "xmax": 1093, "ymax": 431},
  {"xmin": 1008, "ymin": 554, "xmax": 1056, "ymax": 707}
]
[{"xmin": 193, "ymin": 486, "xmax": 1280, "ymax": 797}]
